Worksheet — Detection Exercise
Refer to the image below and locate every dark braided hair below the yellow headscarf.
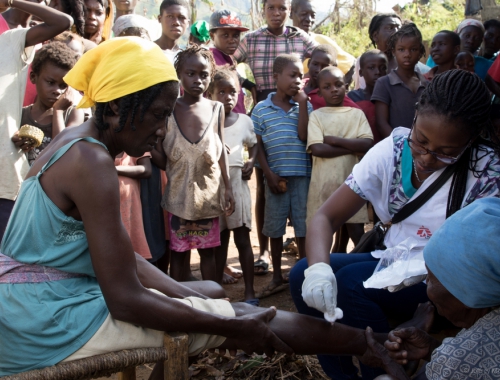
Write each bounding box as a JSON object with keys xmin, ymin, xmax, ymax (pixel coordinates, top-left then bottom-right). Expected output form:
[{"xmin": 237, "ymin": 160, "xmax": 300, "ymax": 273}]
[{"xmin": 94, "ymin": 81, "xmax": 179, "ymax": 132}]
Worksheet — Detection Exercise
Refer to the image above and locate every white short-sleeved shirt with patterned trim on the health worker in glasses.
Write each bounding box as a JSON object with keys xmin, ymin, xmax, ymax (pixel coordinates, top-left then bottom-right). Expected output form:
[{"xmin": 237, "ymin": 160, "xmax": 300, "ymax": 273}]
[{"xmin": 346, "ymin": 127, "xmax": 500, "ymax": 258}]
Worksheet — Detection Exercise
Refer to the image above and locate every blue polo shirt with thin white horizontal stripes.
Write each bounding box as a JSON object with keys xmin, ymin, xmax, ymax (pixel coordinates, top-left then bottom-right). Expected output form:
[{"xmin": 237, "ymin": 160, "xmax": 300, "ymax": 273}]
[{"xmin": 252, "ymin": 92, "xmax": 313, "ymax": 177}]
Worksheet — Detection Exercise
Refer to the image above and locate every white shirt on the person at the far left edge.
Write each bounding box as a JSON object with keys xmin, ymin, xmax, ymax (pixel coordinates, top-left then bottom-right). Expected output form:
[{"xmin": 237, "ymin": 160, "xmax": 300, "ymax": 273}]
[{"xmin": 0, "ymin": 29, "xmax": 34, "ymax": 200}]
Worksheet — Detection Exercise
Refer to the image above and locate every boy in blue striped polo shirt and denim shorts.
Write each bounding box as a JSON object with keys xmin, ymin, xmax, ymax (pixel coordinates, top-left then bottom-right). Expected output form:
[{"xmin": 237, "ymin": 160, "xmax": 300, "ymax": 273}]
[{"xmin": 252, "ymin": 54, "xmax": 313, "ymax": 296}]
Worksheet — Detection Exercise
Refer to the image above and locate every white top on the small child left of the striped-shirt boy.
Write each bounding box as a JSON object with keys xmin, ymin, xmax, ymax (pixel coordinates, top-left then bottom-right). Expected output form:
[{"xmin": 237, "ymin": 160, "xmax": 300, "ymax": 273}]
[{"xmin": 224, "ymin": 113, "xmax": 257, "ymax": 168}]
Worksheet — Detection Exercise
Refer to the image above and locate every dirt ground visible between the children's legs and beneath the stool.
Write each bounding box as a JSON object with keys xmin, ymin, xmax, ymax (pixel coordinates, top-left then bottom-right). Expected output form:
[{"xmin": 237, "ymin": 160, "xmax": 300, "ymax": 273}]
[{"xmin": 98, "ymin": 176, "xmax": 353, "ymax": 380}]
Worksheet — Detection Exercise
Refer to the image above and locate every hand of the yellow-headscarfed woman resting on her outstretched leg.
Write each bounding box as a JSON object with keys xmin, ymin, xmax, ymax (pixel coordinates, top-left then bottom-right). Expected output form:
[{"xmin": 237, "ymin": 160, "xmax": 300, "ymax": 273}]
[{"xmin": 231, "ymin": 306, "xmax": 293, "ymax": 356}]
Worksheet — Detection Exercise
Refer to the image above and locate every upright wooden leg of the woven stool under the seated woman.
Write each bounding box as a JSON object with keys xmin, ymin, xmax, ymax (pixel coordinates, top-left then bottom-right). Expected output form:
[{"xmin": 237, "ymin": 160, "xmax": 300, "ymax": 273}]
[{"xmin": 163, "ymin": 333, "xmax": 189, "ymax": 380}]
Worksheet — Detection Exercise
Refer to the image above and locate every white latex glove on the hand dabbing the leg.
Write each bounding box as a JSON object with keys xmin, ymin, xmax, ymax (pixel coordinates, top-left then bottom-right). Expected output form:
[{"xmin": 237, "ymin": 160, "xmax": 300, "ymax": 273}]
[{"xmin": 302, "ymin": 263, "xmax": 344, "ymax": 322}]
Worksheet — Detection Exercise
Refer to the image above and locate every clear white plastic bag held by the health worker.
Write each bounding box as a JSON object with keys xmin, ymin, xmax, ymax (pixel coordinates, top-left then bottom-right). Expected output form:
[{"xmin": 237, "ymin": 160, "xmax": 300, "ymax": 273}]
[{"xmin": 363, "ymin": 237, "xmax": 427, "ymax": 292}]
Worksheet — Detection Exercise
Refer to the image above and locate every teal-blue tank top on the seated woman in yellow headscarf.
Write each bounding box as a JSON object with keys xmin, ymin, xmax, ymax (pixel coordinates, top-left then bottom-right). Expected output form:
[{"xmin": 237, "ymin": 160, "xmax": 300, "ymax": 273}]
[{"xmin": 0, "ymin": 137, "xmax": 109, "ymax": 377}]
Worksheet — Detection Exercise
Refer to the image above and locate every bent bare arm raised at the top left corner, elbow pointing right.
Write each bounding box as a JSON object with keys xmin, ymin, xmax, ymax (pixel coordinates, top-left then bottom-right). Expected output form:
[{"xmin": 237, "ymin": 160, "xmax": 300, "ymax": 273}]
[{"xmin": 5, "ymin": 0, "xmax": 73, "ymax": 47}]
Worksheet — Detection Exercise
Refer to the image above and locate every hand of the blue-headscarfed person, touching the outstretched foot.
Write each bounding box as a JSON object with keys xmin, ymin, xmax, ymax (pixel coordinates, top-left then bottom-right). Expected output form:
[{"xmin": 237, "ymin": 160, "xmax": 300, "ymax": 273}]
[{"xmin": 384, "ymin": 327, "xmax": 439, "ymax": 365}]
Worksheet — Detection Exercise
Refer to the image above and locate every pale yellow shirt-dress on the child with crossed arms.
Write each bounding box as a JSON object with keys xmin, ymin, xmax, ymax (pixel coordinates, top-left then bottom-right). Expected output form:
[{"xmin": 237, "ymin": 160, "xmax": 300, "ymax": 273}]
[{"xmin": 306, "ymin": 107, "xmax": 373, "ymax": 223}]
